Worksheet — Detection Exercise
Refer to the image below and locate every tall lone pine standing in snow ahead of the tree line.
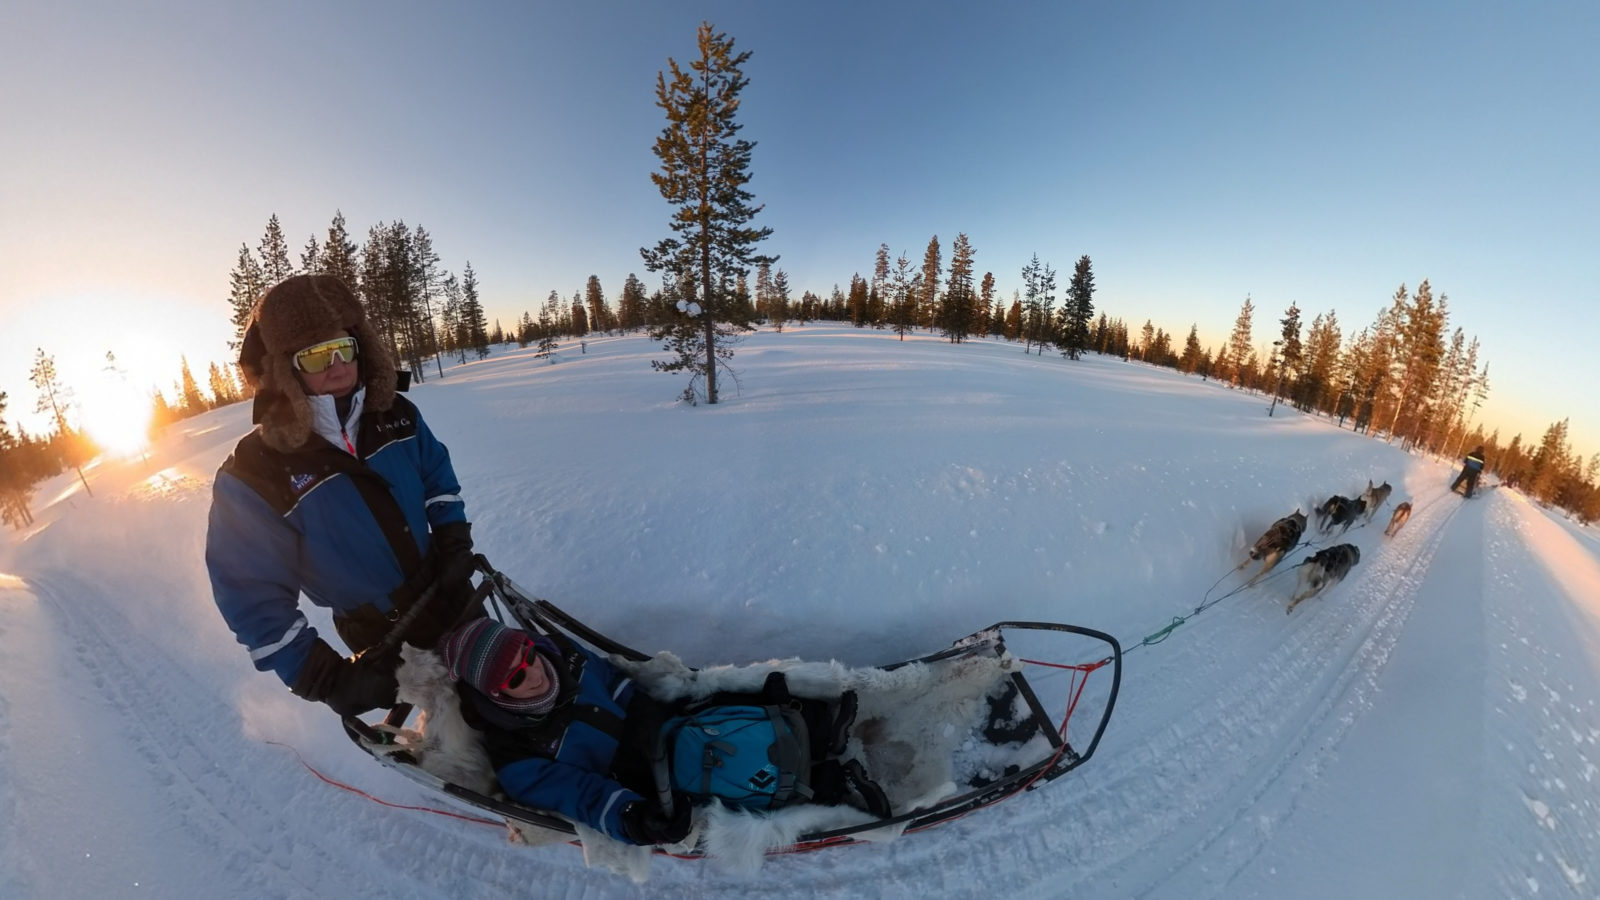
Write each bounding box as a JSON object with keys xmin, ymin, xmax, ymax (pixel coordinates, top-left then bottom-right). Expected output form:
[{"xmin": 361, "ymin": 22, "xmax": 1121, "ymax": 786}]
[{"xmin": 640, "ymin": 22, "xmax": 778, "ymax": 404}]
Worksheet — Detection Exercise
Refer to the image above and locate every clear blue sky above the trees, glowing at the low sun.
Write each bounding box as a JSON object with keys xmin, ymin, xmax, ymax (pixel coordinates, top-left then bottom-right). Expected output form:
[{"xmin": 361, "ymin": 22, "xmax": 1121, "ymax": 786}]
[{"xmin": 0, "ymin": 0, "xmax": 1600, "ymax": 455}]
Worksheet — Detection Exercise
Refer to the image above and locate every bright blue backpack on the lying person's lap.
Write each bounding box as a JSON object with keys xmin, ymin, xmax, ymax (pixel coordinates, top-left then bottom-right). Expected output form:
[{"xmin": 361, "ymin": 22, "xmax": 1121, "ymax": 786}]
[{"xmin": 658, "ymin": 706, "xmax": 811, "ymax": 809}]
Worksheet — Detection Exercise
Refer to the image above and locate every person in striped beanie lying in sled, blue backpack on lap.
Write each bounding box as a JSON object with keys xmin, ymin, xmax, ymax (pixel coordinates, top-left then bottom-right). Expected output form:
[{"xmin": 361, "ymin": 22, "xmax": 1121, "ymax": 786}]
[{"xmin": 438, "ymin": 618, "xmax": 890, "ymax": 844}]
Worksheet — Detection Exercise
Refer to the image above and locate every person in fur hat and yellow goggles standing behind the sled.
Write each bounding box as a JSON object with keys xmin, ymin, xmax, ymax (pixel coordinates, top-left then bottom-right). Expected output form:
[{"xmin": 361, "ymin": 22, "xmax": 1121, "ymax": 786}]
[{"xmin": 206, "ymin": 275, "xmax": 482, "ymax": 716}]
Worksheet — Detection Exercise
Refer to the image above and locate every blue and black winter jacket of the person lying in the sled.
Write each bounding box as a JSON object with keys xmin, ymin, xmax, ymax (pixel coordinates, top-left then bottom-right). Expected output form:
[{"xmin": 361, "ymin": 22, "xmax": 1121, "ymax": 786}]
[{"xmin": 461, "ymin": 636, "xmax": 648, "ymax": 841}]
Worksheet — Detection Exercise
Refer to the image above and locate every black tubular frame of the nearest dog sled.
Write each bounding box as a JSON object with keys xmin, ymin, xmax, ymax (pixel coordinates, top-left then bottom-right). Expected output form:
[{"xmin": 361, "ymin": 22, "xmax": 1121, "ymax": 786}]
[{"xmin": 344, "ymin": 556, "xmax": 1122, "ymax": 858}]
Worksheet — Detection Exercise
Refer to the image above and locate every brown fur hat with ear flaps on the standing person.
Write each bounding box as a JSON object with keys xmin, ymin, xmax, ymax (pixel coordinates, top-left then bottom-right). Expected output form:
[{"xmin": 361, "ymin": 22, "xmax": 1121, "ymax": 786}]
[{"xmin": 238, "ymin": 275, "xmax": 395, "ymax": 452}]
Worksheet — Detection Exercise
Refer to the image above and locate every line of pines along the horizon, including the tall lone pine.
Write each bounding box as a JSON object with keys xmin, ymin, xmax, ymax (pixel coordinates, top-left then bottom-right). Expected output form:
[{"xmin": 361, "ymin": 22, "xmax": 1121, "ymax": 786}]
[{"xmin": 0, "ymin": 22, "xmax": 1600, "ymax": 520}]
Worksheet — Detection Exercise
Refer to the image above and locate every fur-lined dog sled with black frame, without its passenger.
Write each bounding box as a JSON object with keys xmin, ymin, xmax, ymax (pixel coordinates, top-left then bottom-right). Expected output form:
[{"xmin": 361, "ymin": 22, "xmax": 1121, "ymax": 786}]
[{"xmin": 344, "ymin": 557, "xmax": 1123, "ymax": 865}]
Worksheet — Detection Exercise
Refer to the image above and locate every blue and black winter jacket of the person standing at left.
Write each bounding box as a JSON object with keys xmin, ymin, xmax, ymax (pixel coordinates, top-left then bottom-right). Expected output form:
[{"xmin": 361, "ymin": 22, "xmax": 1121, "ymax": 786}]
[{"xmin": 206, "ymin": 396, "xmax": 466, "ymax": 685}]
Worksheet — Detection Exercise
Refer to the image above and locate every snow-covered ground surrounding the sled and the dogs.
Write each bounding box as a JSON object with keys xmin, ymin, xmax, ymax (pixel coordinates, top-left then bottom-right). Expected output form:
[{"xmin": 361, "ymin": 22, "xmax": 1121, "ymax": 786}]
[{"xmin": 0, "ymin": 325, "xmax": 1600, "ymax": 900}]
